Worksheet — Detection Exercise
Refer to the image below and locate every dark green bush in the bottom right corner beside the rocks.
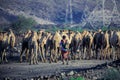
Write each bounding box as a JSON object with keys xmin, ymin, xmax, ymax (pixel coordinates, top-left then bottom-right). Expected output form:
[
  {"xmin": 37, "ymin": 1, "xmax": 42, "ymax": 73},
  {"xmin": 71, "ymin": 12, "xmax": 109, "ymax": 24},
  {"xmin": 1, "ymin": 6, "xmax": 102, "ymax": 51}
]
[{"xmin": 103, "ymin": 68, "xmax": 120, "ymax": 80}]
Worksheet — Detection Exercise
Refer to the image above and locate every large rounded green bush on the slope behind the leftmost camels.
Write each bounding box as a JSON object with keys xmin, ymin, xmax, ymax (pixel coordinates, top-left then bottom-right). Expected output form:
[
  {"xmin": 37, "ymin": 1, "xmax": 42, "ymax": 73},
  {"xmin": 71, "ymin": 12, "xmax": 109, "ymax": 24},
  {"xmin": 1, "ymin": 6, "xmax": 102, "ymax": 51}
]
[{"xmin": 11, "ymin": 15, "xmax": 37, "ymax": 33}]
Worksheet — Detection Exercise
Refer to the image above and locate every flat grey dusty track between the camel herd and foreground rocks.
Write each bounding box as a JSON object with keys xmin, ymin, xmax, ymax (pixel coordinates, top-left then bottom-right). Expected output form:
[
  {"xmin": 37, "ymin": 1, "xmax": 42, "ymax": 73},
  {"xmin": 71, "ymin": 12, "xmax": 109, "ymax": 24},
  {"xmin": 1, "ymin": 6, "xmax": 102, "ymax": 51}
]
[{"xmin": 0, "ymin": 60, "xmax": 110, "ymax": 79}]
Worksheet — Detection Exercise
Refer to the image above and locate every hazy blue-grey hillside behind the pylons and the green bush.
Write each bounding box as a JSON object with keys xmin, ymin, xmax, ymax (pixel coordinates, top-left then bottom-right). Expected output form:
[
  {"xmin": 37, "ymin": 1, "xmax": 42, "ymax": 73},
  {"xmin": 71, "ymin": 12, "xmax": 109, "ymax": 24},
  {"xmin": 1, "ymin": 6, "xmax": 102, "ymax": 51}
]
[{"xmin": 0, "ymin": 0, "xmax": 120, "ymax": 27}]
